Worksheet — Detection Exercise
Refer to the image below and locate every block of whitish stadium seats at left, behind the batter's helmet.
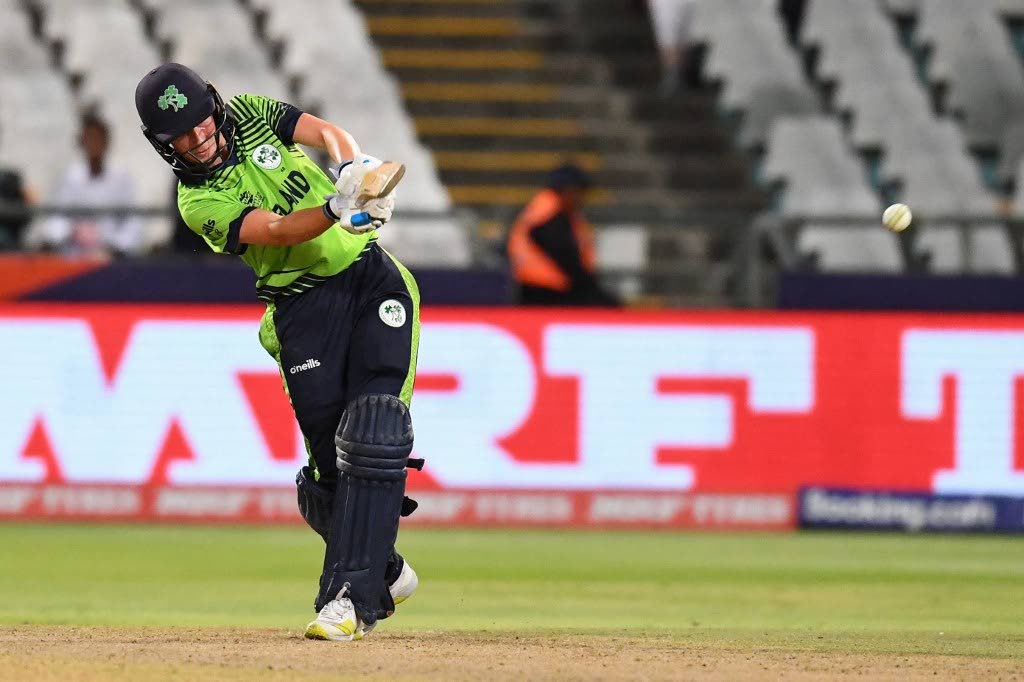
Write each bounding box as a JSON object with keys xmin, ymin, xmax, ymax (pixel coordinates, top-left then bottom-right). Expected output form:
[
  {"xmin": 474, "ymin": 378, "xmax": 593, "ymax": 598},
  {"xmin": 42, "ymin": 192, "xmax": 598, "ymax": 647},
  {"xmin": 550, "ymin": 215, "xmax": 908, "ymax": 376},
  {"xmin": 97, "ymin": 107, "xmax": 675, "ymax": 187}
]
[{"xmin": 0, "ymin": 0, "xmax": 452, "ymax": 263}]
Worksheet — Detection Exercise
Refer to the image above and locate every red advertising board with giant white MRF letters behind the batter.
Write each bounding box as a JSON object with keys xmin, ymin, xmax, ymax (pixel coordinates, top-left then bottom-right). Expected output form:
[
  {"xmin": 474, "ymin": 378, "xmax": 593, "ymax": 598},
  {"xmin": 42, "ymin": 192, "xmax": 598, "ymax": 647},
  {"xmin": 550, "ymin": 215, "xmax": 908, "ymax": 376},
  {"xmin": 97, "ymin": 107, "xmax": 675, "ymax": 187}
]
[{"xmin": 0, "ymin": 305, "xmax": 1024, "ymax": 494}]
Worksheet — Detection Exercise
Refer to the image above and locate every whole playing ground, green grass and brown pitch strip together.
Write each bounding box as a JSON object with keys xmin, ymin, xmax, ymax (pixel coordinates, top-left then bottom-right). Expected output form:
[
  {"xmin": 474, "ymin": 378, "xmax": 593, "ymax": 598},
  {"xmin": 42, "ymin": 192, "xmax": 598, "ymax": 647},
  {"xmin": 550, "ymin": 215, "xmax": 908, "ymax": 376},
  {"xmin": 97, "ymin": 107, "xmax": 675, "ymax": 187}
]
[{"xmin": 0, "ymin": 524, "xmax": 1024, "ymax": 682}]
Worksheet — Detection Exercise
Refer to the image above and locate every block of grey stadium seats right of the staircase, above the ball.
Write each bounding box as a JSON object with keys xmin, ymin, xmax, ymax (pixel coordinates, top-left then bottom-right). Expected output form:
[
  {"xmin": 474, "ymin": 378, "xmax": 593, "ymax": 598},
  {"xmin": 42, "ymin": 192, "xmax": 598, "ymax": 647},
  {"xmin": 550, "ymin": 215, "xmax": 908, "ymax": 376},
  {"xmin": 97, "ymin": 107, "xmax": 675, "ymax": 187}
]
[{"xmin": 698, "ymin": 0, "xmax": 1024, "ymax": 272}]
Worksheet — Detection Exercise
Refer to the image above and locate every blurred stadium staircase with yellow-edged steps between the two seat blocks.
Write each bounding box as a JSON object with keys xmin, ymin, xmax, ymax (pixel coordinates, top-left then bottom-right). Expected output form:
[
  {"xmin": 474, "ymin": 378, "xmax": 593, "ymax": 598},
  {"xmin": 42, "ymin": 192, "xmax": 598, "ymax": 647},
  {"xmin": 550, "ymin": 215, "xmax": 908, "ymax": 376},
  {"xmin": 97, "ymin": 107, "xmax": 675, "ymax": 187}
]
[{"xmin": 356, "ymin": 0, "xmax": 764, "ymax": 305}]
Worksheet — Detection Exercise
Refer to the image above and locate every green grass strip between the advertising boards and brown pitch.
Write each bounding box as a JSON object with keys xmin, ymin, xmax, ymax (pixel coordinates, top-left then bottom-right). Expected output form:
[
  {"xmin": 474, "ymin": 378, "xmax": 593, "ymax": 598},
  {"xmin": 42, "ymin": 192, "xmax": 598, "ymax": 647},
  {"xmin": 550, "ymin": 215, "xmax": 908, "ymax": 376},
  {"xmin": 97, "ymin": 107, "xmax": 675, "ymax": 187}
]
[{"xmin": 0, "ymin": 524, "xmax": 1024, "ymax": 657}]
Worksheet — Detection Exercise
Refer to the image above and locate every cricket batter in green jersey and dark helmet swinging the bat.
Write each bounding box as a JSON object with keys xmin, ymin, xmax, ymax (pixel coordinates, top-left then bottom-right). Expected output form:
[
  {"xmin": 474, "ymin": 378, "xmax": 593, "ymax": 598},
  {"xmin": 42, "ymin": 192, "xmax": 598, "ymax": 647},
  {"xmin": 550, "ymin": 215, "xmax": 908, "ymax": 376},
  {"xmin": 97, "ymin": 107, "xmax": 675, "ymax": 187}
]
[{"xmin": 135, "ymin": 62, "xmax": 422, "ymax": 640}]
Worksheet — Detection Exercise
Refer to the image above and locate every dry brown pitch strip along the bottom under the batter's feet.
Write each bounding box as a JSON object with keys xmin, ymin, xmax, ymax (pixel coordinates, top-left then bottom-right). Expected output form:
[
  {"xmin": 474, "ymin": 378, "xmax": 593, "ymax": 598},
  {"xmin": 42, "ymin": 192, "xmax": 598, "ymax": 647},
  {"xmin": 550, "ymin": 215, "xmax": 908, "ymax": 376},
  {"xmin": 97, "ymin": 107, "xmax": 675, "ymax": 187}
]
[{"xmin": 0, "ymin": 627, "xmax": 1024, "ymax": 682}]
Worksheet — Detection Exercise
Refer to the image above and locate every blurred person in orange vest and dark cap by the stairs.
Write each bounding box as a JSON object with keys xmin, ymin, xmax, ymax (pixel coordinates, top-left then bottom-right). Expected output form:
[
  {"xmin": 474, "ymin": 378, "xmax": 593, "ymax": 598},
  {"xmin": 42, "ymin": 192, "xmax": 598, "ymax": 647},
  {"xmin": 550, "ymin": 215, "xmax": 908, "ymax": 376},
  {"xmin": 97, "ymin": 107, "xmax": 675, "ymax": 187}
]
[{"xmin": 509, "ymin": 164, "xmax": 618, "ymax": 305}]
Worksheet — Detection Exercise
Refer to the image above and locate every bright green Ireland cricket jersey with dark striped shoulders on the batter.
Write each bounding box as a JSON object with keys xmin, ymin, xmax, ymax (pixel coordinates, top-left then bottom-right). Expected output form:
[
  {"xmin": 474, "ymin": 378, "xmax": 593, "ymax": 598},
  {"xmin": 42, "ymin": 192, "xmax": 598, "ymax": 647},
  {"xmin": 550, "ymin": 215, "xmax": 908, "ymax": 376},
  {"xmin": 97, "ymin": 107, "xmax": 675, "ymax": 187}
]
[{"xmin": 178, "ymin": 94, "xmax": 377, "ymax": 302}]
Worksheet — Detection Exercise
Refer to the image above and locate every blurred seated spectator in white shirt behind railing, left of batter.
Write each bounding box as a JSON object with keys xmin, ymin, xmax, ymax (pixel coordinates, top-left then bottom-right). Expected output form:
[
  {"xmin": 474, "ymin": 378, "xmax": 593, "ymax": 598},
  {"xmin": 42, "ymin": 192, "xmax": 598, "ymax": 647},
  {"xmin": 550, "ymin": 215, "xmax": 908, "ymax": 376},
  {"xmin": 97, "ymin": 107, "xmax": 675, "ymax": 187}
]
[{"xmin": 42, "ymin": 114, "xmax": 142, "ymax": 257}]
